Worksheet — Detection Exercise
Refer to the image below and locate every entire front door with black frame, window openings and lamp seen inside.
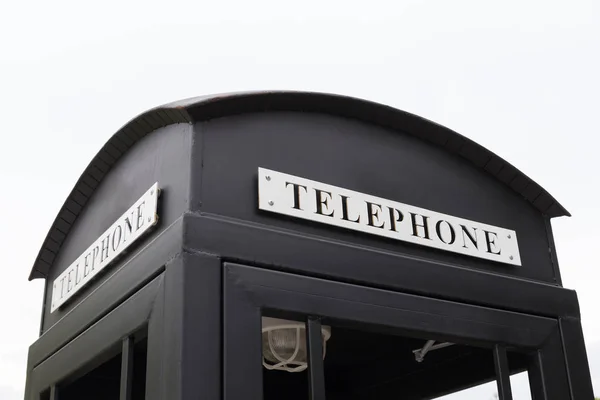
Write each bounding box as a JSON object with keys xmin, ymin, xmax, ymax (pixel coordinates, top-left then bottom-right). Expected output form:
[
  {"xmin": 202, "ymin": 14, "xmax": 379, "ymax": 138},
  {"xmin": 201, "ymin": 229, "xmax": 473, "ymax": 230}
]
[{"xmin": 223, "ymin": 264, "xmax": 571, "ymax": 400}]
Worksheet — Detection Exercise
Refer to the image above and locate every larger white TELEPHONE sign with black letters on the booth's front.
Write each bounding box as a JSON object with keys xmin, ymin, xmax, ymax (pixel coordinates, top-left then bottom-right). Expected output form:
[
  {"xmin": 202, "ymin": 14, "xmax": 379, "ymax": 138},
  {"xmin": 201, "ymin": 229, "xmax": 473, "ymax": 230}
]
[{"xmin": 258, "ymin": 168, "xmax": 521, "ymax": 266}]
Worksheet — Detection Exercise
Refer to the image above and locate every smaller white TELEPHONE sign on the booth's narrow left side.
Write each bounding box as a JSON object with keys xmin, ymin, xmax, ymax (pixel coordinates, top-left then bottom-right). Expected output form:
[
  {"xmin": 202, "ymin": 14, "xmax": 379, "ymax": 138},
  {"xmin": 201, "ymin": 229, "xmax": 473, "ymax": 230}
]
[{"xmin": 50, "ymin": 183, "xmax": 159, "ymax": 312}]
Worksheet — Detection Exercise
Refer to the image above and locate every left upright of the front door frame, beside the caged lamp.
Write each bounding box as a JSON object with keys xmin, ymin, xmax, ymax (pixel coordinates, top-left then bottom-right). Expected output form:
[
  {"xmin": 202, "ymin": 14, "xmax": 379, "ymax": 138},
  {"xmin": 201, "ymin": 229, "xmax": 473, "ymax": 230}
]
[{"xmin": 223, "ymin": 266, "xmax": 263, "ymax": 400}]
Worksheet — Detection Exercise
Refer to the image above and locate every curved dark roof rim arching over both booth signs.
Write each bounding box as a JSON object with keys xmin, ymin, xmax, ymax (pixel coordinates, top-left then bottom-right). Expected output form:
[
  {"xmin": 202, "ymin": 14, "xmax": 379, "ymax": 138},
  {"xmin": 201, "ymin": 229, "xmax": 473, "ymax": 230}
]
[{"xmin": 29, "ymin": 91, "xmax": 570, "ymax": 280}]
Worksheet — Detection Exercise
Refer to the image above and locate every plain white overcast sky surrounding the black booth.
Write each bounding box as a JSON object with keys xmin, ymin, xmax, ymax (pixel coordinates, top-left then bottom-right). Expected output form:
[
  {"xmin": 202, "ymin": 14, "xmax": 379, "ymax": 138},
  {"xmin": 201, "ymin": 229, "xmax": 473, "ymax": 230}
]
[{"xmin": 0, "ymin": 0, "xmax": 600, "ymax": 400}]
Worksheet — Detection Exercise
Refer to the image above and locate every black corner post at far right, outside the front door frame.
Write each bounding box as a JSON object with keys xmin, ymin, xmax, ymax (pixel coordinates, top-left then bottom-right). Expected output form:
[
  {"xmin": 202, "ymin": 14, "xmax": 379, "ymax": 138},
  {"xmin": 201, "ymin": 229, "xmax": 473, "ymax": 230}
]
[{"xmin": 559, "ymin": 318, "xmax": 594, "ymax": 400}]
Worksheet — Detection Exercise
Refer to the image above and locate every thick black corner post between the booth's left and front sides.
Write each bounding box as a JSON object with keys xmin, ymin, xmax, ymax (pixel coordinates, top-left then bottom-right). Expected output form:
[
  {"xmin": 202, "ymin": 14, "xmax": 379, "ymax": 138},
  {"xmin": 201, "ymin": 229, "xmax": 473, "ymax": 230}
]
[{"xmin": 146, "ymin": 253, "xmax": 223, "ymax": 400}]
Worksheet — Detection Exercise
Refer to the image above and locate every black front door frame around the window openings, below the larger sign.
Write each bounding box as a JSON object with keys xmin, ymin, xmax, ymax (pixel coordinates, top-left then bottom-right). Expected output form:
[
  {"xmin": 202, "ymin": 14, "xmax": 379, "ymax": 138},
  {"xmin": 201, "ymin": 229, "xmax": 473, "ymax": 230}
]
[{"xmin": 223, "ymin": 262, "xmax": 571, "ymax": 400}]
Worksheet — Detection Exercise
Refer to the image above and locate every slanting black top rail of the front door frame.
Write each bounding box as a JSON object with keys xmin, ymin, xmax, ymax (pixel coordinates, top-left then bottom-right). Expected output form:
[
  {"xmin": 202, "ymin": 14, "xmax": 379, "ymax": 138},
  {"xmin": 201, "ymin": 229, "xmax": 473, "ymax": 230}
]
[{"xmin": 225, "ymin": 263, "xmax": 558, "ymax": 349}]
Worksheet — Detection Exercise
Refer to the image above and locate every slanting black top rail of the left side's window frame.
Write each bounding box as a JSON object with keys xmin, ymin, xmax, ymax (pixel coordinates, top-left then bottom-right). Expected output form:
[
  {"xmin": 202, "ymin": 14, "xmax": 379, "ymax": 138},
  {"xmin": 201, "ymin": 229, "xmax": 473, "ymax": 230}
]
[{"xmin": 26, "ymin": 276, "xmax": 162, "ymax": 400}]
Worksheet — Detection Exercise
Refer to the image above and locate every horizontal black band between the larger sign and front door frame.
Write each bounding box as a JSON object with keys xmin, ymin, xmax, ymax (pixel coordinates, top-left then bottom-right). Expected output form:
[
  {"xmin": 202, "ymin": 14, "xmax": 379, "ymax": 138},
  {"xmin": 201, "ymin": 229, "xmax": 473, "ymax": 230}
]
[{"xmin": 184, "ymin": 214, "xmax": 579, "ymax": 316}]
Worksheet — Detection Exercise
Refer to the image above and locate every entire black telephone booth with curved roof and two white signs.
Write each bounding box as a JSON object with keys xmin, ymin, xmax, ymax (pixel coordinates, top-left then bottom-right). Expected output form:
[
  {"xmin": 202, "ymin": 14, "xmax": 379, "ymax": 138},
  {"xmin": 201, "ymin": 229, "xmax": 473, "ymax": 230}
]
[{"xmin": 26, "ymin": 92, "xmax": 593, "ymax": 400}]
